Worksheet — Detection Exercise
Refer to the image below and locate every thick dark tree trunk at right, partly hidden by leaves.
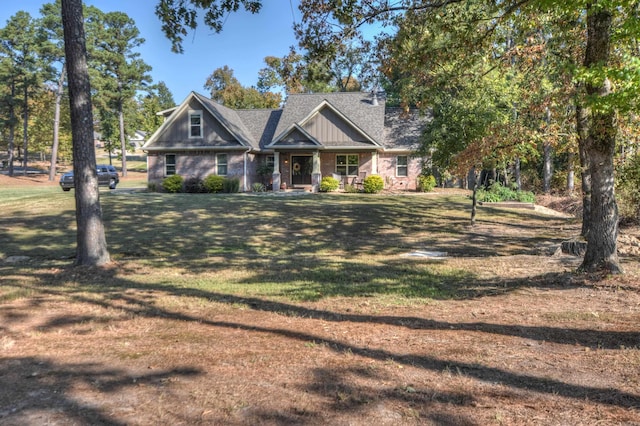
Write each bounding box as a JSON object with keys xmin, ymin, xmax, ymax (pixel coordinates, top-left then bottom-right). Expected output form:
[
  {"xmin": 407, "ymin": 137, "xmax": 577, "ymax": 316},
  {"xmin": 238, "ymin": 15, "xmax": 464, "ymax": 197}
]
[{"xmin": 580, "ymin": 2, "xmax": 623, "ymax": 273}]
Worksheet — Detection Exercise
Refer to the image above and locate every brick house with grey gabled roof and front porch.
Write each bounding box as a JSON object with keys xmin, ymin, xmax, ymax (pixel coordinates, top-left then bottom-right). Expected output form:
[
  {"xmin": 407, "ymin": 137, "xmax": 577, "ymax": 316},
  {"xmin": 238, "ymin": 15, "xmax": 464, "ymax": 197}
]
[{"xmin": 142, "ymin": 92, "xmax": 424, "ymax": 191}]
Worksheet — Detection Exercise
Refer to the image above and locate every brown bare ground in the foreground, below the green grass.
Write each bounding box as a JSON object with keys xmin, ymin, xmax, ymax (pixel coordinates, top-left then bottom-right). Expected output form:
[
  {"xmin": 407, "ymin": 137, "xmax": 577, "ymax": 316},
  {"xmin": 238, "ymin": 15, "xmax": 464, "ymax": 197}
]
[{"xmin": 0, "ymin": 171, "xmax": 640, "ymax": 425}]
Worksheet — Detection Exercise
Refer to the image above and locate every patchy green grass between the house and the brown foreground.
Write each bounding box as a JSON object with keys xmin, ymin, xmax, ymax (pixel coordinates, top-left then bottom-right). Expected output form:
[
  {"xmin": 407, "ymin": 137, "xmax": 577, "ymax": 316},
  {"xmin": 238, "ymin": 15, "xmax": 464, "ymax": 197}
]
[{"xmin": 0, "ymin": 186, "xmax": 576, "ymax": 304}]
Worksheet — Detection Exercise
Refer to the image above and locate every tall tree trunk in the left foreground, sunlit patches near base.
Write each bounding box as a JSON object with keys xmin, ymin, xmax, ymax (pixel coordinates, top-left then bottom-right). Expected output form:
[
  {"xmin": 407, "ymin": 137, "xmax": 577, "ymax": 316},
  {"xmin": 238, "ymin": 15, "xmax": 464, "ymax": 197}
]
[{"xmin": 62, "ymin": 0, "xmax": 110, "ymax": 266}]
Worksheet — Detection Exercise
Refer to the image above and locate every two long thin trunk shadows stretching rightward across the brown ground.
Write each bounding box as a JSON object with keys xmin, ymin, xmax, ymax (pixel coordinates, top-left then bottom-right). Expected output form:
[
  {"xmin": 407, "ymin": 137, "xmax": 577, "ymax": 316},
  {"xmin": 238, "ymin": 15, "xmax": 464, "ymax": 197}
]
[{"xmin": 20, "ymin": 271, "xmax": 640, "ymax": 400}]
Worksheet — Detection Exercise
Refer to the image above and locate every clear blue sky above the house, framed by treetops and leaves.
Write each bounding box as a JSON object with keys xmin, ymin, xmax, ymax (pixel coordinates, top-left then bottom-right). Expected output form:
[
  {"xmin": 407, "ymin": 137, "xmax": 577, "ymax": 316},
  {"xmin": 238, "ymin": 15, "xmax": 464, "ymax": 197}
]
[{"xmin": 0, "ymin": 0, "xmax": 300, "ymax": 103}]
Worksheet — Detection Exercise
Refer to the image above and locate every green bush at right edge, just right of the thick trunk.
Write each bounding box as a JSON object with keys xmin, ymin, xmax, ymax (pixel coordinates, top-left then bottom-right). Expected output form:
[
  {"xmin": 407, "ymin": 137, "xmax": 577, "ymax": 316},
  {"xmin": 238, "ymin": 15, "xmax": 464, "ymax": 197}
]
[{"xmin": 616, "ymin": 154, "xmax": 640, "ymax": 223}]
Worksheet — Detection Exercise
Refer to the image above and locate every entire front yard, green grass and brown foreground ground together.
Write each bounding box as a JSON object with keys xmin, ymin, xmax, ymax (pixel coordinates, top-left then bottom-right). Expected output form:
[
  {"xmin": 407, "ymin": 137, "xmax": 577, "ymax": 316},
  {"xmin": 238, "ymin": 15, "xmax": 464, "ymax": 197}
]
[{"xmin": 0, "ymin": 181, "xmax": 640, "ymax": 425}]
